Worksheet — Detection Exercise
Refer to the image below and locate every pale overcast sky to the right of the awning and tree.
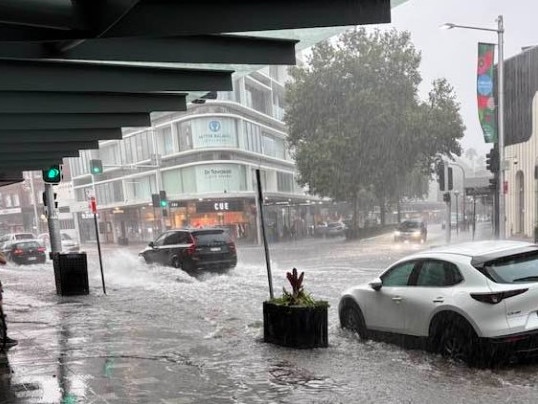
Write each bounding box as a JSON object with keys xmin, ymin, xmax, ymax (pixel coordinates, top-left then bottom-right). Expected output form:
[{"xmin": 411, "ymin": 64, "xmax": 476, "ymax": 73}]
[{"xmin": 368, "ymin": 0, "xmax": 538, "ymax": 154}]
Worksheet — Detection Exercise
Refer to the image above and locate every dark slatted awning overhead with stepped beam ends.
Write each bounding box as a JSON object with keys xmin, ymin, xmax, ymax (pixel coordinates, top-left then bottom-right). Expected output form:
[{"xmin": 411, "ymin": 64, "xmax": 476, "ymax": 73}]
[{"xmin": 0, "ymin": 0, "xmax": 390, "ymax": 185}]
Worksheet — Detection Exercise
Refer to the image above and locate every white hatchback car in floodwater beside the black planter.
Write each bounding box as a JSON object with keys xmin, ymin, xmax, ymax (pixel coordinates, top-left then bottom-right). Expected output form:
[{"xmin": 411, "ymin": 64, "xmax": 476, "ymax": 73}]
[{"xmin": 338, "ymin": 240, "xmax": 538, "ymax": 363}]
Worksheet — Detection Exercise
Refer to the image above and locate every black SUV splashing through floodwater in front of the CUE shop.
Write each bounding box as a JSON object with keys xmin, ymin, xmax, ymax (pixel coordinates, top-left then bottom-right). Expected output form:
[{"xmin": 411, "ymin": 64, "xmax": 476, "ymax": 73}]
[{"xmin": 139, "ymin": 228, "xmax": 237, "ymax": 272}]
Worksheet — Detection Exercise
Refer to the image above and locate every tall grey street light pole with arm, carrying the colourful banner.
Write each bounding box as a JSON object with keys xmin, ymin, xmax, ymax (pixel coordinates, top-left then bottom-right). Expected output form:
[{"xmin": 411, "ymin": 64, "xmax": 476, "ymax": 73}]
[{"xmin": 442, "ymin": 15, "xmax": 506, "ymax": 239}]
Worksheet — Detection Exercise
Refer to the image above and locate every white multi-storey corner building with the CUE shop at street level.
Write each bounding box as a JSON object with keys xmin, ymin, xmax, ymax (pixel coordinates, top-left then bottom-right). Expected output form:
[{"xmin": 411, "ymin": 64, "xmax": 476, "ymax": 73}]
[{"xmin": 68, "ymin": 66, "xmax": 320, "ymax": 243}]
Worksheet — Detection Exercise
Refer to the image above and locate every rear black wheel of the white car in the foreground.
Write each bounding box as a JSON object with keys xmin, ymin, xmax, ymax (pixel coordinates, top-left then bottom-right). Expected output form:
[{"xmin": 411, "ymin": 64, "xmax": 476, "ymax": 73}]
[{"xmin": 439, "ymin": 320, "xmax": 479, "ymax": 365}]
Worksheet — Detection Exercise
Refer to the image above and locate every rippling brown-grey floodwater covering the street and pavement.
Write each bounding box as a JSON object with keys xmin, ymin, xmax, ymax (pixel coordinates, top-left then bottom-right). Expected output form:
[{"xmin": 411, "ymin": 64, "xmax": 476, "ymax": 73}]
[{"xmin": 0, "ymin": 224, "xmax": 538, "ymax": 403}]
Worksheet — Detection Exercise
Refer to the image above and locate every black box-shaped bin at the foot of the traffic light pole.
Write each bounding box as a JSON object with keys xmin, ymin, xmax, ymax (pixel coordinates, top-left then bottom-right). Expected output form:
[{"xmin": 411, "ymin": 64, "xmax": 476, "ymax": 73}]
[{"xmin": 51, "ymin": 252, "xmax": 90, "ymax": 296}]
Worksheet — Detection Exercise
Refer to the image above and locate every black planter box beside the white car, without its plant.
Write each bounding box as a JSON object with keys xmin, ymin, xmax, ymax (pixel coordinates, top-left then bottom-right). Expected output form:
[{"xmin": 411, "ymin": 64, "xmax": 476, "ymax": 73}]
[{"xmin": 263, "ymin": 301, "xmax": 329, "ymax": 348}]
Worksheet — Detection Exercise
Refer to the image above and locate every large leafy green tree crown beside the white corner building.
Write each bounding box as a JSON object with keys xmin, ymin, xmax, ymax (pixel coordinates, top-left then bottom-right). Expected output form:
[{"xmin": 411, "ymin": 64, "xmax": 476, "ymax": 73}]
[{"xmin": 285, "ymin": 29, "xmax": 463, "ymax": 227}]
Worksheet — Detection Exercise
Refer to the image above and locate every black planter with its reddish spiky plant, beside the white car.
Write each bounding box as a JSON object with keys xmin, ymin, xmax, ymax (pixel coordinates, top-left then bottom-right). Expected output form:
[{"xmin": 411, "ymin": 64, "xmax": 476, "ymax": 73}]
[{"xmin": 263, "ymin": 268, "xmax": 329, "ymax": 348}]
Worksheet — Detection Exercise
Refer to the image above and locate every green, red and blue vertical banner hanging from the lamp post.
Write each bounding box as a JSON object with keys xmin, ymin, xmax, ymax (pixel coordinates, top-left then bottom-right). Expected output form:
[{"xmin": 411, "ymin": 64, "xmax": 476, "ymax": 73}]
[{"xmin": 476, "ymin": 43, "xmax": 497, "ymax": 143}]
